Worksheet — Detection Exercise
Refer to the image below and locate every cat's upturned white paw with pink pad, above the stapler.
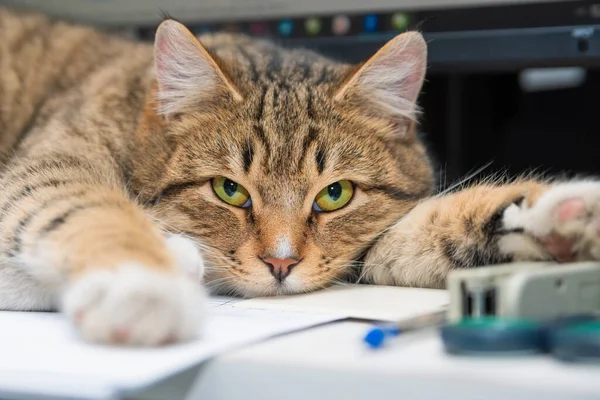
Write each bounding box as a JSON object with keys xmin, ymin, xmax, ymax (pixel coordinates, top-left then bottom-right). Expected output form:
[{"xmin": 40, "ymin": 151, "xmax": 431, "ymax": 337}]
[{"xmin": 504, "ymin": 181, "xmax": 600, "ymax": 262}]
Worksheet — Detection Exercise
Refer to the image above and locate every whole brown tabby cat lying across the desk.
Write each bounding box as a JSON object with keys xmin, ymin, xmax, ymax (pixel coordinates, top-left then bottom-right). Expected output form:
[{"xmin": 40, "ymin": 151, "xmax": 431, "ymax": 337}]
[{"xmin": 0, "ymin": 9, "xmax": 600, "ymax": 345}]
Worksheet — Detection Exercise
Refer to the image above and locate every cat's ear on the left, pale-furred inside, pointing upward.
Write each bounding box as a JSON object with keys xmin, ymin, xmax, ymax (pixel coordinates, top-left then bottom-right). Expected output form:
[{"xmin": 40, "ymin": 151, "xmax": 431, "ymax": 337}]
[{"xmin": 154, "ymin": 19, "xmax": 242, "ymax": 115}]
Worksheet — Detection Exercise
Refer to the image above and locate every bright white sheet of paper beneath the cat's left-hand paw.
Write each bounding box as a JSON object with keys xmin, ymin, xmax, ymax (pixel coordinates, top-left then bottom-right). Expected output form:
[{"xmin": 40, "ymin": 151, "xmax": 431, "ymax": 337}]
[{"xmin": 0, "ymin": 299, "xmax": 336, "ymax": 399}]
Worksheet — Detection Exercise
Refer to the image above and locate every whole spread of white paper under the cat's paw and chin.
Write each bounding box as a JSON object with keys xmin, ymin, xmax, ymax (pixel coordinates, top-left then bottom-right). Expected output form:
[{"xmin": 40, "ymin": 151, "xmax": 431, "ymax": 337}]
[{"xmin": 0, "ymin": 285, "xmax": 448, "ymax": 399}]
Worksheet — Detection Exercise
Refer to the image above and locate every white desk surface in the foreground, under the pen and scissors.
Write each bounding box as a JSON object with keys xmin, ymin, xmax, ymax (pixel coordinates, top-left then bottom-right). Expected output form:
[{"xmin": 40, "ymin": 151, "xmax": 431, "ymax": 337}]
[{"xmin": 131, "ymin": 322, "xmax": 600, "ymax": 400}]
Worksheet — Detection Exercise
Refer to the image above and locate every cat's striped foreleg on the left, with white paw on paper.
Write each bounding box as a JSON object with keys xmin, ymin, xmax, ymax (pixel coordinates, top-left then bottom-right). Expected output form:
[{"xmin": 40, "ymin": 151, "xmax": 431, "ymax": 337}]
[{"xmin": 0, "ymin": 151, "xmax": 205, "ymax": 345}]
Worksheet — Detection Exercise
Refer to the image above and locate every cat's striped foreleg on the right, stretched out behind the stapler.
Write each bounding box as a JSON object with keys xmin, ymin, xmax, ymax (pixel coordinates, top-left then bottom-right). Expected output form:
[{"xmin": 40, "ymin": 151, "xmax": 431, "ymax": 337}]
[{"xmin": 364, "ymin": 181, "xmax": 600, "ymax": 287}]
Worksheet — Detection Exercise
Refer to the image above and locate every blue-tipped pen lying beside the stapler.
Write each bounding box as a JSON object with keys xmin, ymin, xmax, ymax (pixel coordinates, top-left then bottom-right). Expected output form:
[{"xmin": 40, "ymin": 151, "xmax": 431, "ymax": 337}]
[{"xmin": 364, "ymin": 310, "xmax": 448, "ymax": 349}]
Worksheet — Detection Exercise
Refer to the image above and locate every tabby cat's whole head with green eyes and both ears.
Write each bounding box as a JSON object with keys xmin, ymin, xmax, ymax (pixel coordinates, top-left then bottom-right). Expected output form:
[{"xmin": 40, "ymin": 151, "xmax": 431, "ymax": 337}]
[{"xmin": 135, "ymin": 20, "xmax": 433, "ymax": 296}]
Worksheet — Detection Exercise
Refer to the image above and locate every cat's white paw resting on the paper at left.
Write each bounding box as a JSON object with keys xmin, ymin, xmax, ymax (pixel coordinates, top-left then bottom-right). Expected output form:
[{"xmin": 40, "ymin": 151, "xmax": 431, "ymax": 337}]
[{"xmin": 62, "ymin": 263, "xmax": 206, "ymax": 346}]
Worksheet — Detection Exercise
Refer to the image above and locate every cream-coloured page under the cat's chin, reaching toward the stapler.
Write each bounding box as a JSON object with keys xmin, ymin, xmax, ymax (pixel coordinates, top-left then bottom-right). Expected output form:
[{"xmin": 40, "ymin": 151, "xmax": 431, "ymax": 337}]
[{"xmin": 234, "ymin": 285, "xmax": 450, "ymax": 321}]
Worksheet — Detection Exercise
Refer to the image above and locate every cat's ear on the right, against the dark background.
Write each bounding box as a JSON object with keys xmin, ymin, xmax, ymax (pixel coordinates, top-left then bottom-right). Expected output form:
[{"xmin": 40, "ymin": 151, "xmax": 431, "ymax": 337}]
[{"xmin": 334, "ymin": 32, "xmax": 427, "ymax": 120}]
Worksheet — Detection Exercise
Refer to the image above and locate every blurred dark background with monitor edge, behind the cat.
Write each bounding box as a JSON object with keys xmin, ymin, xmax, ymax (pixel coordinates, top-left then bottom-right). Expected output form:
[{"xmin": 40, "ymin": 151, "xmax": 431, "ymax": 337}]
[{"xmin": 0, "ymin": 0, "xmax": 600, "ymax": 183}]
